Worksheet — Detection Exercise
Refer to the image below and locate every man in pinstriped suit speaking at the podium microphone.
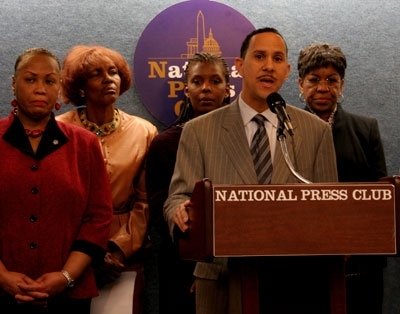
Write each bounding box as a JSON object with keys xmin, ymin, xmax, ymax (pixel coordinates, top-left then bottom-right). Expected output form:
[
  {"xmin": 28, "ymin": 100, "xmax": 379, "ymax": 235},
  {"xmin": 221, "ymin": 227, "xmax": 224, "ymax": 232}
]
[{"xmin": 164, "ymin": 28, "xmax": 337, "ymax": 314}]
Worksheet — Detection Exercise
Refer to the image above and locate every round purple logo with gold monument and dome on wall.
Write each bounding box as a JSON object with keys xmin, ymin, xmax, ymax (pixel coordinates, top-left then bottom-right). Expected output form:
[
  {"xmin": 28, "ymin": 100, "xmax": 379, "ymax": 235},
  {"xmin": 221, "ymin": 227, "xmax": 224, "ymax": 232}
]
[{"xmin": 133, "ymin": 0, "xmax": 254, "ymax": 125}]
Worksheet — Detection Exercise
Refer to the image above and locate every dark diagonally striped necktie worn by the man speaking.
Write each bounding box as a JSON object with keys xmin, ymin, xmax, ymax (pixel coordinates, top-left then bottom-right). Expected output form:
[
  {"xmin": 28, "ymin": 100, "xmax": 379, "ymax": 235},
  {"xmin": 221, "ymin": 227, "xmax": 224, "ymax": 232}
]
[{"xmin": 250, "ymin": 114, "xmax": 272, "ymax": 184}]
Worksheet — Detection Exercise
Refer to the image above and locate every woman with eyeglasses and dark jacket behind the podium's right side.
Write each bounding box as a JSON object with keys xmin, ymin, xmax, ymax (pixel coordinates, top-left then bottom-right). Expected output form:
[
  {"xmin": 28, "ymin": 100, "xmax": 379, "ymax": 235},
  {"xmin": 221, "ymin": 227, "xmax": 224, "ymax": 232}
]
[{"xmin": 297, "ymin": 43, "xmax": 387, "ymax": 314}]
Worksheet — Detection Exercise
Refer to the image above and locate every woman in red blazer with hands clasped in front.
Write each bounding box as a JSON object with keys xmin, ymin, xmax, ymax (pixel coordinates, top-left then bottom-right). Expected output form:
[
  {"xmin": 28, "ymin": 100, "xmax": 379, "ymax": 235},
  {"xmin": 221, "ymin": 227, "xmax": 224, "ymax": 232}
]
[{"xmin": 0, "ymin": 48, "xmax": 112, "ymax": 314}]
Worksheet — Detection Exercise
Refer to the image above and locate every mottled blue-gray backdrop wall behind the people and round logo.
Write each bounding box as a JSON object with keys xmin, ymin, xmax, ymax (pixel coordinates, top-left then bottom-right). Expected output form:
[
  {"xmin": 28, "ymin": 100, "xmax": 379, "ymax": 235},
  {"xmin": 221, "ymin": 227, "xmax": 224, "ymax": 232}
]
[{"xmin": 0, "ymin": 0, "xmax": 400, "ymax": 174}]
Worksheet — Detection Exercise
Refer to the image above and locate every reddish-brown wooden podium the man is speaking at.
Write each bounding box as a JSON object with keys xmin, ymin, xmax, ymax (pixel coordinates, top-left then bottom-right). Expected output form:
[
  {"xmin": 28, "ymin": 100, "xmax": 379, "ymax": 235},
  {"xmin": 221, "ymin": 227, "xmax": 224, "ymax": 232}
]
[{"xmin": 179, "ymin": 176, "xmax": 400, "ymax": 314}]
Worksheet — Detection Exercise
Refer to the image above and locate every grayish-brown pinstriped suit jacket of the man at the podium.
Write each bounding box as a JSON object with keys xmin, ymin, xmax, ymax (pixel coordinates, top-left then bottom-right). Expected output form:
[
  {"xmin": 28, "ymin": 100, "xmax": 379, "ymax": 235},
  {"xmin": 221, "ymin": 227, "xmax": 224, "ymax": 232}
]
[{"xmin": 164, "ymin": 100, "xmax": 337, "ymax": 312}]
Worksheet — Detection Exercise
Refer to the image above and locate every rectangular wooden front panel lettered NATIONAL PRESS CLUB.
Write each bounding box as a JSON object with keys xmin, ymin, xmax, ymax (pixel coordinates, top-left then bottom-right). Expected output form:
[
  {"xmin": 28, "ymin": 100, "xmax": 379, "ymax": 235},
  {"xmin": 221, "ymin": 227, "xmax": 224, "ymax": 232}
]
[{"xmin": 213, "ymin": 184, "xmax": 396, "ymax": 256}]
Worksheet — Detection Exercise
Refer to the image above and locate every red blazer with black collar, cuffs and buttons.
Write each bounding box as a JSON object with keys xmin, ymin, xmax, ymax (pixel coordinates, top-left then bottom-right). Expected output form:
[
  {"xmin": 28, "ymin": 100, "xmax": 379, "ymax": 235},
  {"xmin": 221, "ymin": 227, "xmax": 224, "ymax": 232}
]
[{"xmin": 0, "ymin": 114, "xmax": 112, "ymax": 298}]
